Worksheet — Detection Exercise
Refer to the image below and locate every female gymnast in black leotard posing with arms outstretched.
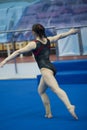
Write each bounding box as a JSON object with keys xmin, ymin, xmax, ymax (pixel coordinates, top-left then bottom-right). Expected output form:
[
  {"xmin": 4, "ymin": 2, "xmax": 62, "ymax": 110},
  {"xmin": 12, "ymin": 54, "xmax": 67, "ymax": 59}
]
[{"xmin": 0, "ymin": 24, "xmax": 78, "ymax": 119}]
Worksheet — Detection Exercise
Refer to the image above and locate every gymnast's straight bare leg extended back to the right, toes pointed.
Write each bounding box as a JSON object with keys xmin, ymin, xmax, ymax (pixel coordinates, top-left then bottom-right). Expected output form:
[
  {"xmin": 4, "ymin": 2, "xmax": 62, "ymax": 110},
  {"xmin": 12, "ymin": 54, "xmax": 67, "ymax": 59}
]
[{"xmin": 41, "ymin": 69, "xmax": 78, "ymax": 119}]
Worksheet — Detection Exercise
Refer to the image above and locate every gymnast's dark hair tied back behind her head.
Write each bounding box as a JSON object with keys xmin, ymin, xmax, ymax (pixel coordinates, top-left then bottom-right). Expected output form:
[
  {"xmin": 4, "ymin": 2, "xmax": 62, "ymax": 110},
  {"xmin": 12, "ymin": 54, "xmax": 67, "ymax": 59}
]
[{"xmin": 32, "ymin": 24, "xmax": 47, "ymax": 38}]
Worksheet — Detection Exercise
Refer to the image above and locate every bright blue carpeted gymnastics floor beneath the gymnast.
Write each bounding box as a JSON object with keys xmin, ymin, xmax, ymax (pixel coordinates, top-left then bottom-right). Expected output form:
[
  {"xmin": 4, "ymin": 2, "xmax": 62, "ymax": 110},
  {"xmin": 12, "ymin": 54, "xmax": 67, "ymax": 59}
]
[{"xmin": 0, "ymin": 79, "xmax": 87, "ymax": 130}]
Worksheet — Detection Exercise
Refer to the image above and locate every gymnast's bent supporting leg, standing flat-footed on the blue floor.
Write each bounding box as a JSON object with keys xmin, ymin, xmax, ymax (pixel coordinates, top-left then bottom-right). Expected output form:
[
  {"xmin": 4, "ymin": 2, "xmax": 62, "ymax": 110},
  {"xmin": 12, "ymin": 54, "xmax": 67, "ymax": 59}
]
[{"xmin": 38, "ymin": 77, "xmax": 52, "ymax": 118}]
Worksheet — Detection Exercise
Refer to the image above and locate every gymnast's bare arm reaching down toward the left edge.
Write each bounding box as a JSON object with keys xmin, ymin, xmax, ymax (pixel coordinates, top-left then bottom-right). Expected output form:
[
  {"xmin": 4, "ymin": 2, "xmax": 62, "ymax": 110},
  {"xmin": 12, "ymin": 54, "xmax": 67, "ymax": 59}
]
[{"xmin": 0, "ymin": 42, "xmax": 36, "ymax": 67}]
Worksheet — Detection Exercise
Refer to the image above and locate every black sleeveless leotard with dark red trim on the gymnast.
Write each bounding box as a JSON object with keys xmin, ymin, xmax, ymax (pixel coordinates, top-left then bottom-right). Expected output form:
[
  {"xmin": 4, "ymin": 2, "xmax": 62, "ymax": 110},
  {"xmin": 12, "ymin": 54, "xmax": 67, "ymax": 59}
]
[{"xmin": 33, "ymin": 39, "xmax": 56, "ymax": 75}]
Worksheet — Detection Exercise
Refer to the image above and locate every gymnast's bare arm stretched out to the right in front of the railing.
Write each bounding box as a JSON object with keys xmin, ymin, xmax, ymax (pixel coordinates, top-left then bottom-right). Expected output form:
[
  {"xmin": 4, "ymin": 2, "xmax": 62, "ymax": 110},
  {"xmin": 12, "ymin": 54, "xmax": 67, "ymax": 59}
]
[{"xmin": 48, "ymin": 28, "xmax": 79, "ymax": 42}]
